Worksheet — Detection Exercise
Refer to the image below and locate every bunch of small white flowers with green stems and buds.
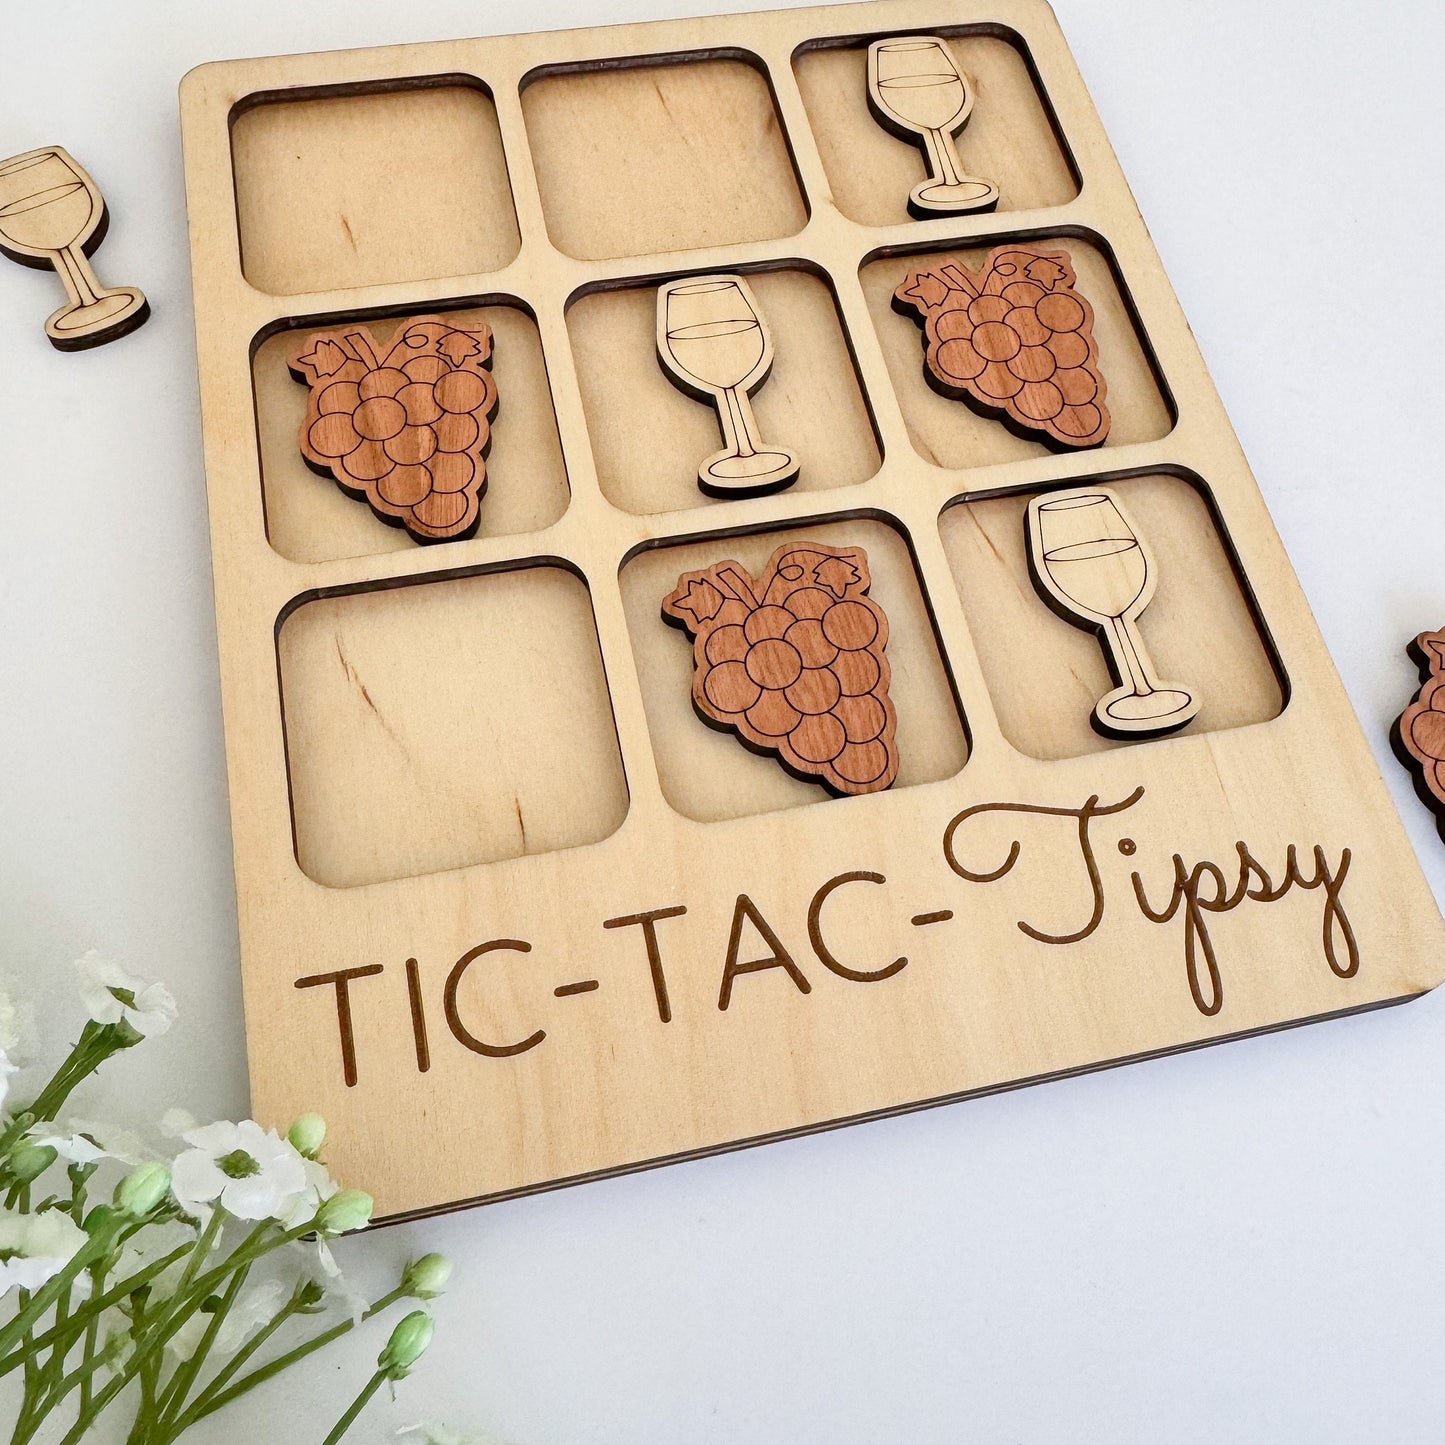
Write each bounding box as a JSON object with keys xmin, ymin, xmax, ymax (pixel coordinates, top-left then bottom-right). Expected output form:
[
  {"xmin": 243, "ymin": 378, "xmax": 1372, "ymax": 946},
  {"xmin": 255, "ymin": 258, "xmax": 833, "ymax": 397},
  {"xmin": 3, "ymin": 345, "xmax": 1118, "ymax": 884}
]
[{"xmin": 0, "ymin": 954, "xmax": 451, "ymax": 1445}]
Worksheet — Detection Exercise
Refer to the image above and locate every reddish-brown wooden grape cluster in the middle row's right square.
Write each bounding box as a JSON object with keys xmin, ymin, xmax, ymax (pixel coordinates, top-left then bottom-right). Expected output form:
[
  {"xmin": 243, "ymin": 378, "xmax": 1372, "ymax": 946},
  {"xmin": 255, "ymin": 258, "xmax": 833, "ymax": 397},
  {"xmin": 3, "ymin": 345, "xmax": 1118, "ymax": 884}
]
[{"xmin": 893, "ymin": 246, "xmax": 1108, "ymax": 449}]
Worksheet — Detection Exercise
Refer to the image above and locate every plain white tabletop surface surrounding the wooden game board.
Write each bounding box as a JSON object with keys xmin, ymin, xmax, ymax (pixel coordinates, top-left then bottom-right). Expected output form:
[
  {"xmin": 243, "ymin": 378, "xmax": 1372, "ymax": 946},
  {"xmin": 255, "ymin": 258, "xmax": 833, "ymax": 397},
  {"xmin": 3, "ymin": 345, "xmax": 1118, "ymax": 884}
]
[{"xmin": 0, "ymin": 0, "xmax": 1445, "ymax": 1445}]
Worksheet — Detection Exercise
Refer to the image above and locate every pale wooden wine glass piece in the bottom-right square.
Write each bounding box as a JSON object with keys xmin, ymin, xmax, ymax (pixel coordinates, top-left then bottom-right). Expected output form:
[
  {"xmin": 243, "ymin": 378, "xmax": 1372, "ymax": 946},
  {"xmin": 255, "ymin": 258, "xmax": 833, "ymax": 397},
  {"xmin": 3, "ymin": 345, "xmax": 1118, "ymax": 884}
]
[{"xmin": 1025, "ymin": 487, "xmax": 1201, "ymax": 738}]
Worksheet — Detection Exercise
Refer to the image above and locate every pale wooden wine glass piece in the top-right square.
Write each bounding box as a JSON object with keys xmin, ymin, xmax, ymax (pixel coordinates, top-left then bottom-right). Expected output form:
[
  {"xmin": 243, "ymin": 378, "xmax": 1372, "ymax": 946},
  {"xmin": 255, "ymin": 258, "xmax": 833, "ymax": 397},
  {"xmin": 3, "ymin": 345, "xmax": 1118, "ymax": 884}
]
[{"xmin": 868, "ymin": 35, "xmax": 998, "ymax": 220}]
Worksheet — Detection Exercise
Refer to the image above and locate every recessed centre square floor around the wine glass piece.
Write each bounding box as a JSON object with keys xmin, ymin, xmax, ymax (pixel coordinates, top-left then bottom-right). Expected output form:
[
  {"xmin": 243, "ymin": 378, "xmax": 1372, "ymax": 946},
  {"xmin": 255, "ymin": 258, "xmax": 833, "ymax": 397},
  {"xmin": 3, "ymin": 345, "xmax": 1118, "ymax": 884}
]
[{"xmin": 566, "ymin": 266, "xmax": 880, "ymax": 513}]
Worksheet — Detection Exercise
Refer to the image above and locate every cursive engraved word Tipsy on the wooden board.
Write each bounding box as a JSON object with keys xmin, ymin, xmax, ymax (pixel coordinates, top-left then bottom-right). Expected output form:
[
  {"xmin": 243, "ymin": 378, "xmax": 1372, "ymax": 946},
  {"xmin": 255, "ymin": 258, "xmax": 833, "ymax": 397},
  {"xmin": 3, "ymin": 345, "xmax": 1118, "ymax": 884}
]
[{"xmin": 944, "ymin": 788, "xmax": 1360, "ymax": 1014}]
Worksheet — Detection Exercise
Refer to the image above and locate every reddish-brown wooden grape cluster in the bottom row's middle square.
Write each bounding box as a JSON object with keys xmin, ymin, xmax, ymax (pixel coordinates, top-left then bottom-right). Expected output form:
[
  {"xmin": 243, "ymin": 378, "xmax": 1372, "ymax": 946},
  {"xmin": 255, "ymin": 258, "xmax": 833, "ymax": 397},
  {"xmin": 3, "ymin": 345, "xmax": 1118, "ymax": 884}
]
[{"xmin": 662, "ymin": 542, "xmax": 899, "ymax": 793}]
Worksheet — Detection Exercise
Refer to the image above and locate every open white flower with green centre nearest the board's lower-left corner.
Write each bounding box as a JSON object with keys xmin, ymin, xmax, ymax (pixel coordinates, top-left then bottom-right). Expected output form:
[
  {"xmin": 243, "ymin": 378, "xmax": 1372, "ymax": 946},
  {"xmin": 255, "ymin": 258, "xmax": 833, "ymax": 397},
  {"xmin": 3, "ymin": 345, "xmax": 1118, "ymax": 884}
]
[{"xmin": 171, "ymin": 1118, "xmax": 306, "ymax": 1220}]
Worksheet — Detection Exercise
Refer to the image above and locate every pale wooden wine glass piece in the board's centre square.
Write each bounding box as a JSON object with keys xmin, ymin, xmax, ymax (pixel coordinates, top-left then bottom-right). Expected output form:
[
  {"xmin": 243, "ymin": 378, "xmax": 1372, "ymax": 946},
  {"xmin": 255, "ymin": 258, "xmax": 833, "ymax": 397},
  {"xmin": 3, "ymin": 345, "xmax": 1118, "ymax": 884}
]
[{"xmin": 657, "ymin": 275, "xmax": 799, "ymax": 497}]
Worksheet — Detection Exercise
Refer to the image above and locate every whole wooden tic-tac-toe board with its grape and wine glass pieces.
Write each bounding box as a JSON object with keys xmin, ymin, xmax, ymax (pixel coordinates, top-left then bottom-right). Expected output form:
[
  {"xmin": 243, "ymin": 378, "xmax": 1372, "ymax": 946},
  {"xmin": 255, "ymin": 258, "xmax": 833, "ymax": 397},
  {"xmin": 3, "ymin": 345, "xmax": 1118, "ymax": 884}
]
[{"xmin": 182, "ymin": 0, "xmax": 1445, "ymax": 1217}]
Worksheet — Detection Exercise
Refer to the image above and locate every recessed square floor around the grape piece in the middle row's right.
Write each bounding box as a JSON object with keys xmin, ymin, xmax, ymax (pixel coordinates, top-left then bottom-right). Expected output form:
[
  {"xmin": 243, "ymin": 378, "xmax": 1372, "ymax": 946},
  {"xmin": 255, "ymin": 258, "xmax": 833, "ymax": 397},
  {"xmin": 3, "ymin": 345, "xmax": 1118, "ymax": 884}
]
[{"xmin": 858, "ymin": 236, "xmax": 1173, "ymax": 470}]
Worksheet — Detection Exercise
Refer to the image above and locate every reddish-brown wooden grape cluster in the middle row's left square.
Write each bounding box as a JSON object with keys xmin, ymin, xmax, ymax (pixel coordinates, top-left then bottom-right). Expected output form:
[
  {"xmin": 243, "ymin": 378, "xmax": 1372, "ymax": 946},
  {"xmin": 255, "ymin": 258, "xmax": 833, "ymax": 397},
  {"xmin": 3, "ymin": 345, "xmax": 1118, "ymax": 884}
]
[{"xmin": 288, "ymin": 316, "xmax": 497, "ymax": 542}]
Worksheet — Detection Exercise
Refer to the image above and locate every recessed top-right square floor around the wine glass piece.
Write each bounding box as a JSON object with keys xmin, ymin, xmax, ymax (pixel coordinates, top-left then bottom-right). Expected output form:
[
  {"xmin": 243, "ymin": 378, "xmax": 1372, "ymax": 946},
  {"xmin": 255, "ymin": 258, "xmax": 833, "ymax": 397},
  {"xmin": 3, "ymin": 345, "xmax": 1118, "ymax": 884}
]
[{"xmin": 793, "ymin": 26, "xmax": 1078, "ymax": 225}]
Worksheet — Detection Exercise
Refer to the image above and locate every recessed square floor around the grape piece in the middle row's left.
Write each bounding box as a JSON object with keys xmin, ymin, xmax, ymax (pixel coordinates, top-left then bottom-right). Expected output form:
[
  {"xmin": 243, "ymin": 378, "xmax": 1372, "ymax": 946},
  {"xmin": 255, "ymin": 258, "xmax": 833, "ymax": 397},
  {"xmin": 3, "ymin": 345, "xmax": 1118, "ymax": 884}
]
[{"xmin": 251, "ymin": 302, "xmax": 571, "ymax": 562}]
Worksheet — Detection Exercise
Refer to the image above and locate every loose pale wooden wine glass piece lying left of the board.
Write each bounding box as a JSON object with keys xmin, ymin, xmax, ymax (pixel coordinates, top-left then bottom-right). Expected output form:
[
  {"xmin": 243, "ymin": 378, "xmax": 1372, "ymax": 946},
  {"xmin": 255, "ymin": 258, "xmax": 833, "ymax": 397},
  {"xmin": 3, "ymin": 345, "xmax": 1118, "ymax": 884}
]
[{"xmin": 0, "ymin": 146, "xmax": 150, "ymax": 351}]
